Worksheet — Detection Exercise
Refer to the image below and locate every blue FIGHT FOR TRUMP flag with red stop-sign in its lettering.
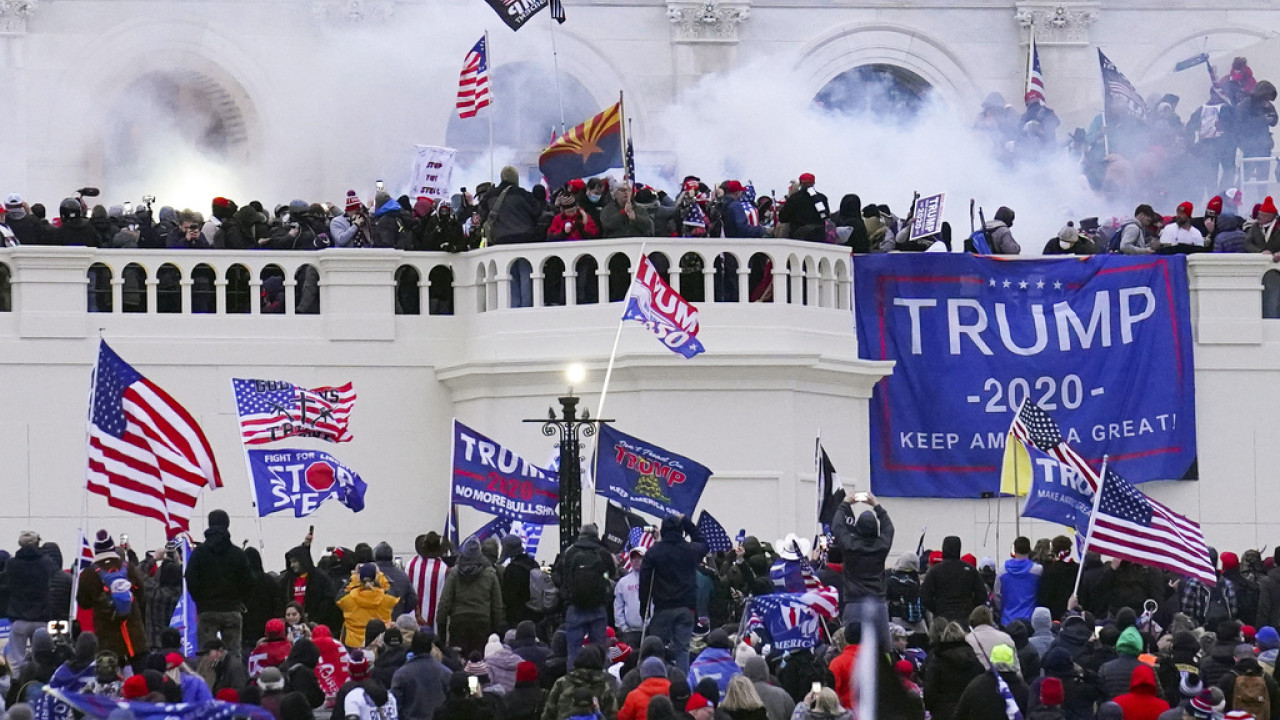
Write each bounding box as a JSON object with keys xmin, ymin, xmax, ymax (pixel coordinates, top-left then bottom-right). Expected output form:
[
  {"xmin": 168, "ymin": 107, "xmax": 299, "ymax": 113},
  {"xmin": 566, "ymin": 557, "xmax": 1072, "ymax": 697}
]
[{"xmin": 246, "ymin": 450, "xmax": 367, "ymax": 518}]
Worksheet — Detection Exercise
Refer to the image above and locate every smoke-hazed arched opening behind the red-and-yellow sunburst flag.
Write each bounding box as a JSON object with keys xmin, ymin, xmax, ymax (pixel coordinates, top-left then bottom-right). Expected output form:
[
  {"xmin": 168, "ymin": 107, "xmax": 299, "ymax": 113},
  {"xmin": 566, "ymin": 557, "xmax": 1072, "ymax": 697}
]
[{"xmin": 445, "ymin": 63, "xmax": 604, "ymax": 181}]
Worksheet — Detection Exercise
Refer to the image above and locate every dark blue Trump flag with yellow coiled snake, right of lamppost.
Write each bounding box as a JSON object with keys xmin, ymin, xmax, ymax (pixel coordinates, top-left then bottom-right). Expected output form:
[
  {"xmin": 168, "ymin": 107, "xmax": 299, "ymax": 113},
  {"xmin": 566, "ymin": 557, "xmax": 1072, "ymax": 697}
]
[{"xmin": 595, "ymin": 424, "xmax": 712, "ymax": 518}]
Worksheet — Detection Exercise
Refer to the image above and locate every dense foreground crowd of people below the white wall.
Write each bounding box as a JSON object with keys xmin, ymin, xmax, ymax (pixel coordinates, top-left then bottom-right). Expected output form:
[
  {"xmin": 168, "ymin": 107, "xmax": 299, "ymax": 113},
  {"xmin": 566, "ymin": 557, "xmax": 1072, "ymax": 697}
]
[{"xmin": 0, "ymin": 493, "xmax": 1280, "ymax": 720}]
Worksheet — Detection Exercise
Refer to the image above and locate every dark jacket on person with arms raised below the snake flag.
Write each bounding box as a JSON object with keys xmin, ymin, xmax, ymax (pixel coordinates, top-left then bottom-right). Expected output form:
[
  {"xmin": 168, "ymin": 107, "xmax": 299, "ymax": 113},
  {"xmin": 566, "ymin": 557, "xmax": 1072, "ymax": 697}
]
[{"xmin": 640, "ymin": 518, "xmax": 707, "ymax": 612}]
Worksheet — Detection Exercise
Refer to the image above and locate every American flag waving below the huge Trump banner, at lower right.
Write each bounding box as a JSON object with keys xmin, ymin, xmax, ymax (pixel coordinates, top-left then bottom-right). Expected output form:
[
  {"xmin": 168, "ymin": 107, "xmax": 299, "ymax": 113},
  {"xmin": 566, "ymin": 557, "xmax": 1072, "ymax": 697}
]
[{"xmin": 1085, "ymin": 468, "xmax": 1217, "ymax": 585}]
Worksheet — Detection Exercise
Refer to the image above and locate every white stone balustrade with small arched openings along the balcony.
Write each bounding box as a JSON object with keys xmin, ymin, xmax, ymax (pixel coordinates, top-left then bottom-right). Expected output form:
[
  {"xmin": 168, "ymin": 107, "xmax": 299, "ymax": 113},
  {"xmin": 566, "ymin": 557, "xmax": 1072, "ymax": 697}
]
[{"xmin": 0, "ymin": 238, "xmax": 851, "ymax": 338}]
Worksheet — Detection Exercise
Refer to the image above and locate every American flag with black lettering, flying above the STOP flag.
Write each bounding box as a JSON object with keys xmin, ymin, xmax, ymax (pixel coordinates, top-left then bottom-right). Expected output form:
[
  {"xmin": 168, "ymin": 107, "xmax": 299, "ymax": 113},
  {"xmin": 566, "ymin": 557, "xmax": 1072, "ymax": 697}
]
[{"xmin": 232, "ymin": 378, "xmax": 356, "ymax": 445}]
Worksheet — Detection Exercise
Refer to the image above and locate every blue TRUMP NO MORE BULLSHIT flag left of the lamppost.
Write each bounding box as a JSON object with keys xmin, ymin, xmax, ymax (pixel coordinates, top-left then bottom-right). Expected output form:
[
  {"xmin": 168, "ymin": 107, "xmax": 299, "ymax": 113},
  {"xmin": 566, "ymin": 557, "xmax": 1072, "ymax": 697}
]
[{"xmin": 453, "ymin": 420, "xmax": 559, "ymax": 525}]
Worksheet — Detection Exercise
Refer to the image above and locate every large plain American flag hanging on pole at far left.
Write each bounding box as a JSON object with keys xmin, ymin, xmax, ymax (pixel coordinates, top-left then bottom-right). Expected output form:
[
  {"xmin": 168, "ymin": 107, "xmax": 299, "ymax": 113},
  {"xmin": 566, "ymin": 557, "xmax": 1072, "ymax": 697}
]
[{"xmin": 86, "ymin": 341, "xmax": 223, "ymax": 538}]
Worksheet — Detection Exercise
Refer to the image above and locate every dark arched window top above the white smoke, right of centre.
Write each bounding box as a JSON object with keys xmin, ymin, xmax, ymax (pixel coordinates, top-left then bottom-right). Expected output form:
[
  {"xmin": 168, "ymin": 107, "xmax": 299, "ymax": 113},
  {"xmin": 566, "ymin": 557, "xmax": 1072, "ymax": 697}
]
[{"xmin": 813, "ymin": 63, "xmax": 933, "ymax": 119}]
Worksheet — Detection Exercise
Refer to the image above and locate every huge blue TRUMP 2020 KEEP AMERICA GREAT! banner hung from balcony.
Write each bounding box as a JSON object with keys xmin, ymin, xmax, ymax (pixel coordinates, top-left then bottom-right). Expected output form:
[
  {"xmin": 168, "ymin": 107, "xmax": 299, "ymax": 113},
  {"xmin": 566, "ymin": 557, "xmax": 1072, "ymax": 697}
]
[{"xmin": 854, "ymin": 254, "xmax": 1196, "ymax": 497}]
